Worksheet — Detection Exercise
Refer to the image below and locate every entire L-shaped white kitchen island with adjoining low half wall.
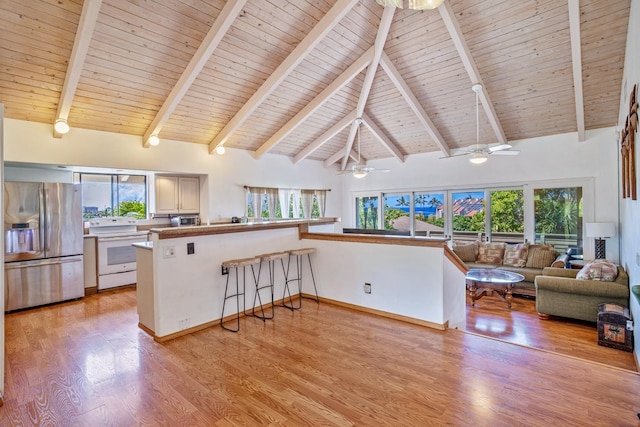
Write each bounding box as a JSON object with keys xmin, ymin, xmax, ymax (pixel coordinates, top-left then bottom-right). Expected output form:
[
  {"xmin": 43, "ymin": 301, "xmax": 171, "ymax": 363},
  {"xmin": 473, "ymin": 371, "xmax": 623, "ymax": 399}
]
[{"xmin": 136, "ymin": 218, "xmax": 465, "ymax": 342}]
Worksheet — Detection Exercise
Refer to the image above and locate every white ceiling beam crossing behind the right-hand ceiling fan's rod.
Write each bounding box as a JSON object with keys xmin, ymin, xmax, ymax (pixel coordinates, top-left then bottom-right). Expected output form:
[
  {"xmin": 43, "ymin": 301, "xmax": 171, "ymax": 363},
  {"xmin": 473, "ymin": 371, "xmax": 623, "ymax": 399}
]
[{"xmin": 438, "ymin": 1, "xmax": 507, "ymax": 144}]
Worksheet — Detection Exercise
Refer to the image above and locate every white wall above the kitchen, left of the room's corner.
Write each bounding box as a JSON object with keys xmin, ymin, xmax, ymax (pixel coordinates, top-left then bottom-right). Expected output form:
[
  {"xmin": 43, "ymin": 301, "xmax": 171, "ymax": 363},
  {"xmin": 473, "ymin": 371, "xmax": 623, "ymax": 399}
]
[{"xmin": 5, "ymin": 119, "xmax": 342, "ymax": 221}]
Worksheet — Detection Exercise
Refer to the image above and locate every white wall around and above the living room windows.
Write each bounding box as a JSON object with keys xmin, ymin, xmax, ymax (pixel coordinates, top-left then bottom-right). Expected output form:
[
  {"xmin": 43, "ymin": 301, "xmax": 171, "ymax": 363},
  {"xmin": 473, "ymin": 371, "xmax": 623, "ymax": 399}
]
[{"xmin": 342, "ymin": 128, "xmax": 619, "ymax": 260}]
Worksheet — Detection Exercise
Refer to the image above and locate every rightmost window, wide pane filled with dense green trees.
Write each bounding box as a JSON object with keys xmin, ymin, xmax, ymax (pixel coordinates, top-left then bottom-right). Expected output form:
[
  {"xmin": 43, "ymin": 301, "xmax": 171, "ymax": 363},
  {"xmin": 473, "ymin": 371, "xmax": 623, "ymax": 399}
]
[{"xmin": 533, "ymin": 187, "xmax": 583, "ymax": 252}]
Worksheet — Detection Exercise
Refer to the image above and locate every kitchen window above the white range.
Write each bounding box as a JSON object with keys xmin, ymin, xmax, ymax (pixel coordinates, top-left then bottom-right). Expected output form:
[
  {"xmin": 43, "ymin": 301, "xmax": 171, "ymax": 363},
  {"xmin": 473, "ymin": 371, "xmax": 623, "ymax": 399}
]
[{"xmin": 75, "ymin": 173, "xmax": 147, "ymax": 219}]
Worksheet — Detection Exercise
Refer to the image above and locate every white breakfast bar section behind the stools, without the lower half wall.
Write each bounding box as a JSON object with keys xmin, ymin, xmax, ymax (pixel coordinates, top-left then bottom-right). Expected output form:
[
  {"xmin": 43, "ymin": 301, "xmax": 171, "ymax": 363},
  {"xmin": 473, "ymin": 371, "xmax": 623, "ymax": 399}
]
[{"xmin": 134, "ymin": 218, "xmax": 338, "ymax": 341}]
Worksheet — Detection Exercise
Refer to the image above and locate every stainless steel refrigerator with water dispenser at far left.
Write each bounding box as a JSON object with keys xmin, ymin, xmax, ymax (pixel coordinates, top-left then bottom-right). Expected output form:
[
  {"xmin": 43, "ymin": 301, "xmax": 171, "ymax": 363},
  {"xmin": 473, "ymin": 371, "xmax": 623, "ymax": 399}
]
[{"xmin": 4, "ymin": 182, "xmax": 84, "ymax": 311}]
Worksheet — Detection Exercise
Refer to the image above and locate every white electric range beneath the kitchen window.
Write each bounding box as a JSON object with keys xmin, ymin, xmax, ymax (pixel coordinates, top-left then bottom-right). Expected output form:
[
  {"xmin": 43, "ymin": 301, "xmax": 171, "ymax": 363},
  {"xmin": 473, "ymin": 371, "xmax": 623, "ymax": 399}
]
[{"xmin": 89, "ymin": 217, "xmax": 148, "ymax": 291}]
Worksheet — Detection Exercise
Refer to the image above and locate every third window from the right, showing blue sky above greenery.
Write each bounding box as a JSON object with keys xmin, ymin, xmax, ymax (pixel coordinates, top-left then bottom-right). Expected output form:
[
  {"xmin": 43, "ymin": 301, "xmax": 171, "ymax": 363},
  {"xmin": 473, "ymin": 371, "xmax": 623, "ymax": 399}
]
[{"xmin": 451, "ymin": 191, "xmax": 485, "ymax": 240}]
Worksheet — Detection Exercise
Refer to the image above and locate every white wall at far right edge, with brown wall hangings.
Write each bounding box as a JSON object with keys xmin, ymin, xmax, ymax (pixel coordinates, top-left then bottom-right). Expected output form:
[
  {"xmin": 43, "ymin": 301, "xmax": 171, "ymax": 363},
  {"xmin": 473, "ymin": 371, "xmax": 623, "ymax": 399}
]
[{"xmin": 616, "ymin": 0, "xmax": 640, "ymax": 360}]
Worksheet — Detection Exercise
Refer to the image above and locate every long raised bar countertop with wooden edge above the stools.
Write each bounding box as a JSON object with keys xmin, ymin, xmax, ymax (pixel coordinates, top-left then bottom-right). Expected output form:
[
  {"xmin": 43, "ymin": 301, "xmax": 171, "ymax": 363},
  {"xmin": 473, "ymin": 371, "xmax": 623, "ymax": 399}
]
[{"xmin": 150, "ymin": 217, "xmax": 338, "ymax": 239}]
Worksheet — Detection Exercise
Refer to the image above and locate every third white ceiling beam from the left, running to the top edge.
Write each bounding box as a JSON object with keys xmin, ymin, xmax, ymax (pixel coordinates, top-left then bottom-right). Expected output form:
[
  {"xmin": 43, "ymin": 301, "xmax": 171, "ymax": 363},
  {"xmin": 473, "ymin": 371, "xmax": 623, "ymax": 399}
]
[{"xmin": 209, "ymin": 0, "xmax": 359, "ymax": 153}]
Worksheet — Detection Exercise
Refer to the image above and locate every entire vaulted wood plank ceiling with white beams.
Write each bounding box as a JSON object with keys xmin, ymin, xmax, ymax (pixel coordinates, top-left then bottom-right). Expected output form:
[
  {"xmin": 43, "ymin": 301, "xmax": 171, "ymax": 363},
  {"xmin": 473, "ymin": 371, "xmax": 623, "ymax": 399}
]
[{"xmin": 0, "ymin": 0, "xmax": 630, "ymax": 167}]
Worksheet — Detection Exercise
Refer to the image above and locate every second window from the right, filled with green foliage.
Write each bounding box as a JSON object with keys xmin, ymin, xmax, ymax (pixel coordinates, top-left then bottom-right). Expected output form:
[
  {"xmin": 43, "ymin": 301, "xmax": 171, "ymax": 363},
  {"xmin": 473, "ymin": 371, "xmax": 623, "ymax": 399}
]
[{"xmin": 489, "ymin": 190, "xmax": 524, "ymax": 243}]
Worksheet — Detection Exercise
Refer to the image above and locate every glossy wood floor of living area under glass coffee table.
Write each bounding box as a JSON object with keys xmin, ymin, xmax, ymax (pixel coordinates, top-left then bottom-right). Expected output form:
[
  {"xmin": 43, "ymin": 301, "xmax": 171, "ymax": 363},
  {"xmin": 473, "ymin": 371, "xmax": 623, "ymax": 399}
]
[{"xmin": 463, "ymin": 296, "xmax": 637, "ymax": 371}]
